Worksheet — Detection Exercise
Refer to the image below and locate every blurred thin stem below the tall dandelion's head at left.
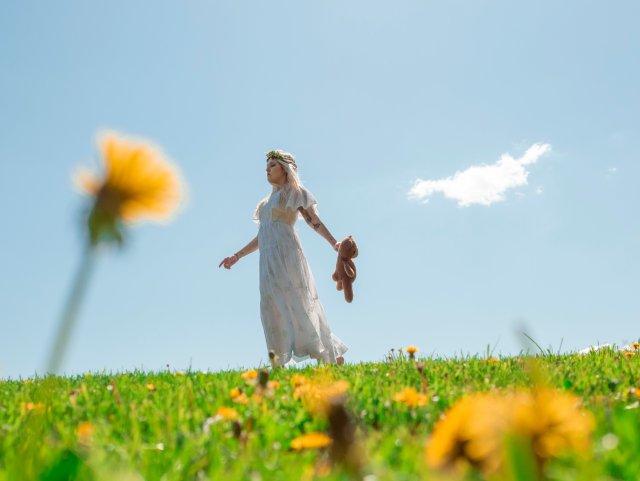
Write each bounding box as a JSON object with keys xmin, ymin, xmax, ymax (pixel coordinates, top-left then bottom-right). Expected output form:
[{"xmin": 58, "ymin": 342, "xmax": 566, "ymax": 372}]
[{"xmin": 47, "ymin": 242, "xmax": 95, "ymax": 374}]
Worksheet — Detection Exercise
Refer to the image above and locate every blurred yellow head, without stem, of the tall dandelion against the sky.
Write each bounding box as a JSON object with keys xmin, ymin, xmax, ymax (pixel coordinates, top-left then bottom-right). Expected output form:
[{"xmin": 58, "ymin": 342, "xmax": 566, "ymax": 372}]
[{"xmin": 74, "ymin": 132, "xmax": 184, "ymax": 244}]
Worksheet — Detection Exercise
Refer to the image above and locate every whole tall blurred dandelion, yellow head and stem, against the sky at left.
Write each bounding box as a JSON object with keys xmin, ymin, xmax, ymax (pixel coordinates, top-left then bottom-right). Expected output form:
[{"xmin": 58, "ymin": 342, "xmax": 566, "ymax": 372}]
[{"xmin": 47, "ymin": 132, "xmax": 185, "ymax": 374}]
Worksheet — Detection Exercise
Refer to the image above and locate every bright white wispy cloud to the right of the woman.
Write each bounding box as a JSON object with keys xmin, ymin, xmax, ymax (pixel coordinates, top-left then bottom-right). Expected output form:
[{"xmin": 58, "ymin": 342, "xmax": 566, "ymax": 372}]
[{"xmin": 407, "ymin": 144, "xmax": 551, "ymax": 207}]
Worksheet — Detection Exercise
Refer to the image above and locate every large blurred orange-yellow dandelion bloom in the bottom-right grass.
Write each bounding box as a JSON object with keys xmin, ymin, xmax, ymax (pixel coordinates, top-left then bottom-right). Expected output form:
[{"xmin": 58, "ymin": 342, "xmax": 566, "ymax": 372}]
[{"xmin": 425, "ymin": 388, "xmax": 595, "ymax": 473}]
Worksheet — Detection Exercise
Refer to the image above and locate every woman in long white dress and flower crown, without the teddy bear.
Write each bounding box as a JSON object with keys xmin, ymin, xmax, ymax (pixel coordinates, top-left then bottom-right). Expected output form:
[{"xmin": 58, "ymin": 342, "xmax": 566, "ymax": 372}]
[{"xmin": 218, "ymin": 150, "xmax": 347, "ymax": 365}]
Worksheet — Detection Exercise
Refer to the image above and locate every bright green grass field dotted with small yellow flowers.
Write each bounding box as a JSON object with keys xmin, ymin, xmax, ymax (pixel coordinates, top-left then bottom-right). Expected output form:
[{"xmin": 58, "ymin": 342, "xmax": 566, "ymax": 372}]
[{"xmin": 0, "ymin": 350, "xmax": 640, "ymax": 481}]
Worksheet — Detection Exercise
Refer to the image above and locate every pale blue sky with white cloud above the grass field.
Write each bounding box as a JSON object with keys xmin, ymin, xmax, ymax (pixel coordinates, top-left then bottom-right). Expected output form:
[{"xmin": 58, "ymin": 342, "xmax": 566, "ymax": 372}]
[{"xmin": 0, "ymin": 0, "xmax": 640, "ymax": 378}]
